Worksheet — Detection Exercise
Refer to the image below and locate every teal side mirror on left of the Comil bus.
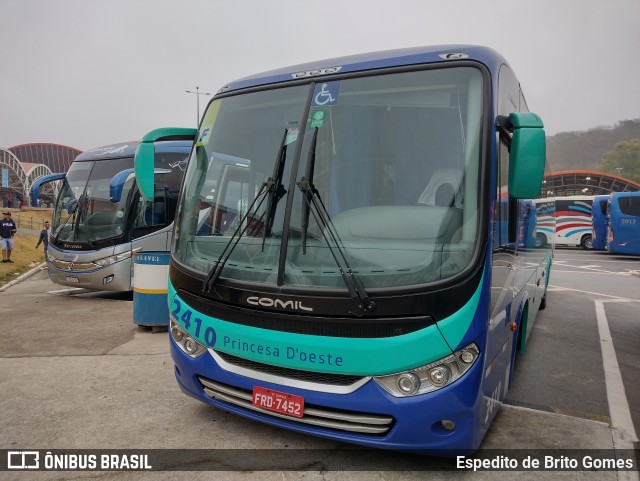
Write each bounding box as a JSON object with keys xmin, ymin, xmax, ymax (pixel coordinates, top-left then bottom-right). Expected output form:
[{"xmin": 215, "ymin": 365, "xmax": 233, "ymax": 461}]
[{"xmin": 133, "ymin": 127, "xmax": 198, "ymax": 201}]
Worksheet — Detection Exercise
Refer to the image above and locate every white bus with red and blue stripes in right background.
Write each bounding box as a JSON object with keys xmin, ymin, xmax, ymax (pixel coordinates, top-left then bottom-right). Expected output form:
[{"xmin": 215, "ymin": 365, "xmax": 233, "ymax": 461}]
[{"xmin": 537, "ymin": 195, "xmax": 594, "ymax": 249}]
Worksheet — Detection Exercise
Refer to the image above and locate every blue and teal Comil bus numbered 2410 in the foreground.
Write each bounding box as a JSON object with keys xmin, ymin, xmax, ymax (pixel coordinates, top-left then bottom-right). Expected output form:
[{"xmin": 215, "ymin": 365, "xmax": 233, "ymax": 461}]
[{"xmin": 136, "ymin": 46, "xmax": 552, "ymax": 454}]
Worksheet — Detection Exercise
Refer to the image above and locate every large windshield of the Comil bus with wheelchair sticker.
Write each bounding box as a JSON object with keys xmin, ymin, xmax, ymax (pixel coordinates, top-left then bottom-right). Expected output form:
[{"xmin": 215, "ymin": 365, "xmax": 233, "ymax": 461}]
[{"xmin": 174, "ymin": 66, "xmax": 486, "ymax": 289}]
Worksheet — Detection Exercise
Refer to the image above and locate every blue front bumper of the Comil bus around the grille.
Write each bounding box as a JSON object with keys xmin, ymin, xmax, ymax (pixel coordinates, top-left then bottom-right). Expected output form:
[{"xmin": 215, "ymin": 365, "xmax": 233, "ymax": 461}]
[{"xmin": 171, "ymin": 339, "xmax": 487, "ymax": 456}]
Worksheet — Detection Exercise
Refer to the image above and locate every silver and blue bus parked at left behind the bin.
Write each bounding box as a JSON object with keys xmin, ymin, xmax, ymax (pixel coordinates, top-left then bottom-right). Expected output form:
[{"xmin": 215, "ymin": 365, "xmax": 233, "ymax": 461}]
[{"xmin": 32, "ymin": 140, "xmax": 193, "ymax": 291}]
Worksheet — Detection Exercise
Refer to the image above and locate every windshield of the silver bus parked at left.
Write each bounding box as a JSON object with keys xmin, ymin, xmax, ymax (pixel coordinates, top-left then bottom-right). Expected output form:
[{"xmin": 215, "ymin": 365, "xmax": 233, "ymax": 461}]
[{"xmin": 52, "ymin": 157, "xmax": 135, "ymax": 244}]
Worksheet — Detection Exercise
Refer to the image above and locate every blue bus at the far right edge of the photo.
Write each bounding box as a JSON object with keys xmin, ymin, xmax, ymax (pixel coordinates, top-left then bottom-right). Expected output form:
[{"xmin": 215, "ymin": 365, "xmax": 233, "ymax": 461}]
[{"xmin": 606, "ymin": 192, "xmax": 640, "ymax": 255}]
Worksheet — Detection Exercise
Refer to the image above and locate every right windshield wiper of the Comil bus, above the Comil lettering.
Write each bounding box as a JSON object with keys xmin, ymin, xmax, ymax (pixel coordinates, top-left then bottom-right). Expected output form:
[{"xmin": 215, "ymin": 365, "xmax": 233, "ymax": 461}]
[{"xmin": 298, "ymin": 176, "xmax": 376, "ymax": 316}]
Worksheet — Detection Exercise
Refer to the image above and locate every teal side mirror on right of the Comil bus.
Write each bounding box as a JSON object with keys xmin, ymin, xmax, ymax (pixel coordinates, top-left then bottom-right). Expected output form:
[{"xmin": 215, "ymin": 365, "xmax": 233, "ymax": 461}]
[{"xmin": 506, "ymin": 112, "xmax": 547, "ymax": 199}]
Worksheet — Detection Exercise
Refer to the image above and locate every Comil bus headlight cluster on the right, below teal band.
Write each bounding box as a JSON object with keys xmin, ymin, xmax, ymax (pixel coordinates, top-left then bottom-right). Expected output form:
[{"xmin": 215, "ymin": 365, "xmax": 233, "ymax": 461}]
[{"xmin": 373, "ymin": 343, "xmax": 480, "ymax": 397}]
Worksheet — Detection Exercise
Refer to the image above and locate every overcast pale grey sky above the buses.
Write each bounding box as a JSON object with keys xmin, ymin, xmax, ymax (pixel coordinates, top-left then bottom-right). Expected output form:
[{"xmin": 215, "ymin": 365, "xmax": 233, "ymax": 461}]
[{"xmin": 0, "ymin": 0, "xmax": 640, "ymax": 150}]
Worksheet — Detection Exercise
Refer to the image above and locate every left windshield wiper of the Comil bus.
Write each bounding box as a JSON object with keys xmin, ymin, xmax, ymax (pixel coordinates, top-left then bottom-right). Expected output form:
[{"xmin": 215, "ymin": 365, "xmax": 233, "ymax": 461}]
[{"xmin": 202, "ymin": 129, "xmax": 287, "ymax": 292}]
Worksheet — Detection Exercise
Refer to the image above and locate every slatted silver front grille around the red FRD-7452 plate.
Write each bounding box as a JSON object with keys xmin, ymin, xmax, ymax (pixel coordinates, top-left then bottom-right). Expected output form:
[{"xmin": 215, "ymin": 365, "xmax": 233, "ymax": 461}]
[{"xmin": 198, "ymin": 376, "xmax": 394, "ymax": 435}]
